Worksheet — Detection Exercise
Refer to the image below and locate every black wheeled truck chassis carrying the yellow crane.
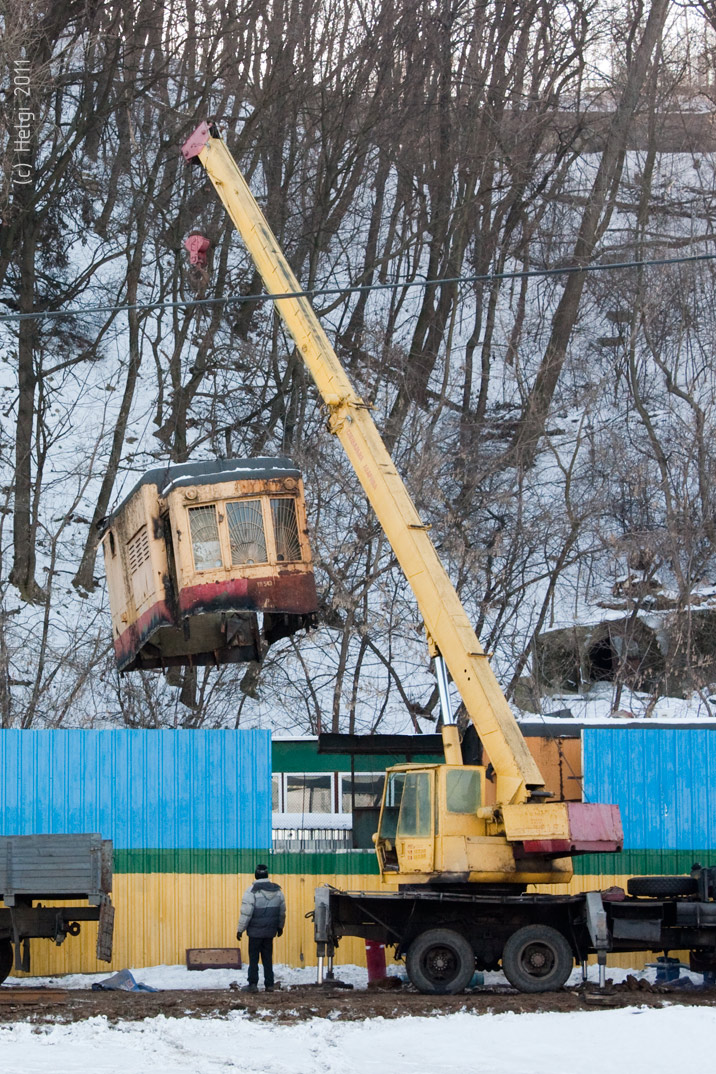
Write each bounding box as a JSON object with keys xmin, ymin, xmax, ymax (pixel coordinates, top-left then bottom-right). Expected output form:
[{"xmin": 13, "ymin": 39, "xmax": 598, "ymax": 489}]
[{"xmin": 313, "ymin": 867, "xmax": 716, "ymax": 995}]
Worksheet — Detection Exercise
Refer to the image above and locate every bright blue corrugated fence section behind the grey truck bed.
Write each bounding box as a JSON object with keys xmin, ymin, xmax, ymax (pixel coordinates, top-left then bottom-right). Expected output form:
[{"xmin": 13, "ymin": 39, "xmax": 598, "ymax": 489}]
[{"xmin": 0, "ymin": 729, "xmax": 271, "ymax": 850}]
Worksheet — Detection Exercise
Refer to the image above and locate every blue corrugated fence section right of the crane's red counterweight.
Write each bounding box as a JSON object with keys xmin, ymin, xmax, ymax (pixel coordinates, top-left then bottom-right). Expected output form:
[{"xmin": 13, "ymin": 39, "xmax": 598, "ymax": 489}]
[{"xmin": 582, "ymin": 727, "xmax": 716, "ymax": 851}]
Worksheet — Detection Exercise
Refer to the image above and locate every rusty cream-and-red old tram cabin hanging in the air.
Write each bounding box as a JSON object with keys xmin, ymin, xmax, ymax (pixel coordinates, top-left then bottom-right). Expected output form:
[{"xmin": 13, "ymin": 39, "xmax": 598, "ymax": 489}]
[{"xmin": 102, "ymin": 458, "xmax": 317, "ymax": 671}]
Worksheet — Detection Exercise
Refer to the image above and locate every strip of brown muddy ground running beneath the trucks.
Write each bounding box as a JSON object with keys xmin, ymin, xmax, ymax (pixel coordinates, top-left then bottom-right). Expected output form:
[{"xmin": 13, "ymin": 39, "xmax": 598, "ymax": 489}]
[{"xmin": 0, "ymin": 985, "xmax": 716, "ymax": 1024}]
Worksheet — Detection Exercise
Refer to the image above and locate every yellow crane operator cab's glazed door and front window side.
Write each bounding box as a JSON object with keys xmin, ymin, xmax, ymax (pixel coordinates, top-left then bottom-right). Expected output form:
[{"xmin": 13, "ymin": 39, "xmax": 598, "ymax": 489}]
[{"xmin": 374, "ymin": 766, "xmax": 437, "ymax": 876}]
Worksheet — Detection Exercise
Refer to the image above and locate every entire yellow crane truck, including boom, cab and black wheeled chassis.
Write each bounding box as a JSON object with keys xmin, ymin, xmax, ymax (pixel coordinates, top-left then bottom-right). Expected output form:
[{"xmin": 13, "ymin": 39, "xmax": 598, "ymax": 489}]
[{"xmin": 181, "ymin": 122, "xmax": 716, "ymax": 993}]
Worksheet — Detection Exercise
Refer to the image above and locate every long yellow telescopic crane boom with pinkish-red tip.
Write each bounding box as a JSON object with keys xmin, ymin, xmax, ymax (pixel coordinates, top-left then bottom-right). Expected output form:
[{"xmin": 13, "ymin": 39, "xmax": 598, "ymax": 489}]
[{"xmin": 182, "ymin": 124, "xmax": 544, "ymax": 804}]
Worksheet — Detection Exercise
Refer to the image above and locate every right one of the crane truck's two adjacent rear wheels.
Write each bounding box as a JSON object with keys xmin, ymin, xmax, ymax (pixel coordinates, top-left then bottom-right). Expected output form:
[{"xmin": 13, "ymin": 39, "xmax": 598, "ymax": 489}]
[{"xmin": 502, "ymin": 925, "xmax": 574, "ymax": 992}]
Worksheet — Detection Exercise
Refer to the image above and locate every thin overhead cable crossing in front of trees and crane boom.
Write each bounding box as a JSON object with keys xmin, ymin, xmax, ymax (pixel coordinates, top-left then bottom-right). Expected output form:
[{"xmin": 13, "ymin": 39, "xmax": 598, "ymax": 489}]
[{"xmin": 0, "ymin": 253, "xmax": 716, "ymax": 323}]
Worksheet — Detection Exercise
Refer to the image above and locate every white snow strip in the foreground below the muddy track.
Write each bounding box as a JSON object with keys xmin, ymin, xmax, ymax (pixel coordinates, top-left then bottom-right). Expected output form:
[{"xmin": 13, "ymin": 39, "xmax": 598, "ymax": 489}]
[{"xmin": 0, "ymin": 1006, "xmax": 716, "ymax": 1074}]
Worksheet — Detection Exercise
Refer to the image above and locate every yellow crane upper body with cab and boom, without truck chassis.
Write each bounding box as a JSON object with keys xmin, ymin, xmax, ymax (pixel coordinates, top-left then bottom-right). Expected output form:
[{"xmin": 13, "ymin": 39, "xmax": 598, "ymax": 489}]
[{"xmin": 182, "ymin": 122, "xmax": 622, "ymax": 887}]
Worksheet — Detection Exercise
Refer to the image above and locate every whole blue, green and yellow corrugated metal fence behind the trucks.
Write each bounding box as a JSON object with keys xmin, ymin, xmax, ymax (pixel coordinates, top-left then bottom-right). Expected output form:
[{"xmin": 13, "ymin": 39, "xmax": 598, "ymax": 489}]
[{"xmin": 0, "ymin": 726, "xmax": 716, "ymax": 973}]
